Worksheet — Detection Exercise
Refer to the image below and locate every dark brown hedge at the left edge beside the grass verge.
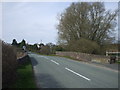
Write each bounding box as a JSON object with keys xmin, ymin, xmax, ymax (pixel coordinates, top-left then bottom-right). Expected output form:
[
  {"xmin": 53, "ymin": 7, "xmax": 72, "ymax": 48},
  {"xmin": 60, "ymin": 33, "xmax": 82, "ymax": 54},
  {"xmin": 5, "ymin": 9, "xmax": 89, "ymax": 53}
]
[{"xmin": 2, "ymin": 42, "xmax": 17, "ymax": 88}]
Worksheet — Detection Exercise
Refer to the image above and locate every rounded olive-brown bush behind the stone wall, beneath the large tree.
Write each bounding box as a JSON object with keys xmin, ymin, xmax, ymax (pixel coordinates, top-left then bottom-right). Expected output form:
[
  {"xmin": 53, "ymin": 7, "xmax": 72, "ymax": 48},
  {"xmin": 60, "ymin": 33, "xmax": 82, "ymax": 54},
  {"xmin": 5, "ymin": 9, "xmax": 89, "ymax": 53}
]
[{"xmin": 67, "ymin": 38, "xmax": 100, "ymax": 54}]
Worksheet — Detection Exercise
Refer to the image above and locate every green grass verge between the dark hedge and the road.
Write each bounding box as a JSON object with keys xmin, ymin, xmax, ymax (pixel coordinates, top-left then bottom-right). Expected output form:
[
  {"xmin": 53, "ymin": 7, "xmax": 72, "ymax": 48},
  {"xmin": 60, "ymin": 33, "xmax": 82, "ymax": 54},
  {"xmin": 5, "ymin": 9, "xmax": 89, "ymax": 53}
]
[{"xmin": 10, "ymin": 56, "xmax": 36, "ymax": 88}]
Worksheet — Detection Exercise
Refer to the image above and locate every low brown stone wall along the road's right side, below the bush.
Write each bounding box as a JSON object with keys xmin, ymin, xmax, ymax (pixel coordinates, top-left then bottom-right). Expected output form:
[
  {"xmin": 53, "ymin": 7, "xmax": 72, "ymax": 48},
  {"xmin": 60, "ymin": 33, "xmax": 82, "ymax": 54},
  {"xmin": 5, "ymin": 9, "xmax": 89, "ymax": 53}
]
[{"xmin": 56, "ymin": 51, "xmax": 109, "ymax": 63}]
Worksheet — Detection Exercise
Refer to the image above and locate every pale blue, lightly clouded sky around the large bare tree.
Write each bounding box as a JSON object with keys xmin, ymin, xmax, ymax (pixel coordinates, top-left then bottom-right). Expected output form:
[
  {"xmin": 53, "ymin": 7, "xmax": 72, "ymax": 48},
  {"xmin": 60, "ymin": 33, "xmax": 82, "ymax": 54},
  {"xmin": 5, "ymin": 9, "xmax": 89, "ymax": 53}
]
[{"xmin": 2, "ymin": 2, "xmax": 118, "ymax": 44}]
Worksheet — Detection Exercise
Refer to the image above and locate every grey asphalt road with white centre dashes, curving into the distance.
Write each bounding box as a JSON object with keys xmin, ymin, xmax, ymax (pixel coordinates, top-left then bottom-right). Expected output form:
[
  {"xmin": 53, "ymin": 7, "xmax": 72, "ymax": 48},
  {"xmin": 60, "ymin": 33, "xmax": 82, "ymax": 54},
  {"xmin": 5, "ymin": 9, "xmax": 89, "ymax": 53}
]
[{"xmin": 29, "ymin": 53, "xmax": 118, "ymax": 88}]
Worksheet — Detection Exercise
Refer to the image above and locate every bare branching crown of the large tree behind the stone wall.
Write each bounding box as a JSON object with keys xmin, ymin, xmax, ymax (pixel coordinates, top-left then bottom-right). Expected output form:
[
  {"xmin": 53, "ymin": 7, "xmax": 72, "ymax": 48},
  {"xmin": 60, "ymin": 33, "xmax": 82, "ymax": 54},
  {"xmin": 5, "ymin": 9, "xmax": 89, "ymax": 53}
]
[{"xmin": 57, "ymin": 2, "xmax": 118, "ymax": 45}]
